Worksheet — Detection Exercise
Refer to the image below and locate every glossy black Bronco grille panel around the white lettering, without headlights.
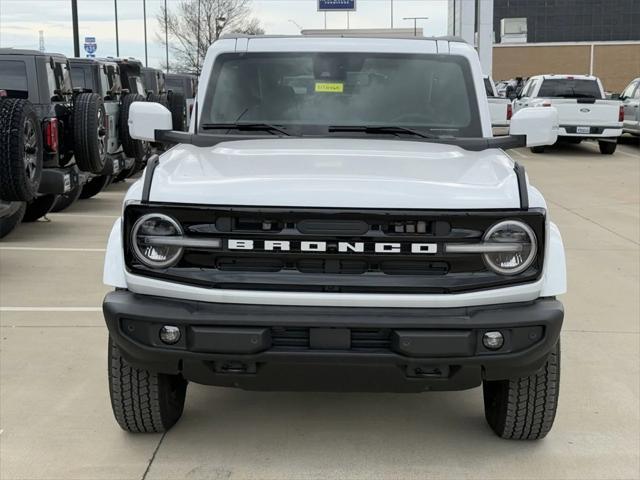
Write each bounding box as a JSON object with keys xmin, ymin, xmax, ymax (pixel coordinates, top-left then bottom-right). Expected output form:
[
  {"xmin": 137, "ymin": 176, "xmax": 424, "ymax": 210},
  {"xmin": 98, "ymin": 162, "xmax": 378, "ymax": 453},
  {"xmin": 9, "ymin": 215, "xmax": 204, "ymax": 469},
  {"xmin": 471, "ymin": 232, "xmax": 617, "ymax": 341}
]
[{"xmin": 123, "ymin": 203, "xmax": 545, "ymax": 294}]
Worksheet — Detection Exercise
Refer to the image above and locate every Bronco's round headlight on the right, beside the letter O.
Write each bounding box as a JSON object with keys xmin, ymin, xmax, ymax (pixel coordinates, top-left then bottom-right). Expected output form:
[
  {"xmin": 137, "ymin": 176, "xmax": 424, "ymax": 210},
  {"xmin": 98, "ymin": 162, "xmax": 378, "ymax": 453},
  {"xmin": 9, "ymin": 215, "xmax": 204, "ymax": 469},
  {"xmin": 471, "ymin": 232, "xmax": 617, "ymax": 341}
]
[{"xmin": 483, "ymin": 220, "xmax": 538, "ymax": 275}]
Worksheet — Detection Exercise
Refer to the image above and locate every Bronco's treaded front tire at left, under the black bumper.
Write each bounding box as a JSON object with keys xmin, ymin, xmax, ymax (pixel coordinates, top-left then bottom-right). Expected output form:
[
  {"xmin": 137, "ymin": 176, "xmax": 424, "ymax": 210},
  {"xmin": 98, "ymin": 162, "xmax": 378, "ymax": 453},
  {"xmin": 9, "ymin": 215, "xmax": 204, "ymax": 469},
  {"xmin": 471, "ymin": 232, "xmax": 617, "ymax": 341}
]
[{"xmin": 108, "ymin": 337, "xmax": 187, "ymax": 433}]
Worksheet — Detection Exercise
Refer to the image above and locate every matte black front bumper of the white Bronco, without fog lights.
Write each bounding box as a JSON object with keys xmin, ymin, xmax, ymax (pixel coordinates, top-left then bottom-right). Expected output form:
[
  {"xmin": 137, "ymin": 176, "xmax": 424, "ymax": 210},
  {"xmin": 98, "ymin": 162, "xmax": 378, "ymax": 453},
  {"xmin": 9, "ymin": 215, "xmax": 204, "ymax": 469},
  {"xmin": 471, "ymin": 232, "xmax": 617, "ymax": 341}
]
[{"xmin": 103, "ymin": 291, "xmax": 564, "ymax": 392}]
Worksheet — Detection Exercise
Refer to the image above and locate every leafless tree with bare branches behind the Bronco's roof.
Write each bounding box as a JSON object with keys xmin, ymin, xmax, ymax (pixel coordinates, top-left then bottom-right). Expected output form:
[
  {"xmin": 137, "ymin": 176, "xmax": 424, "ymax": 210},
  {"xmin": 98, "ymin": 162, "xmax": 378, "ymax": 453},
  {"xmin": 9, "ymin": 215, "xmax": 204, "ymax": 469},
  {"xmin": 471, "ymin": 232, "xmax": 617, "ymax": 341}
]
[{"xmin": 156, "ymin": 0, "xmax": 264, "ymax": 75}]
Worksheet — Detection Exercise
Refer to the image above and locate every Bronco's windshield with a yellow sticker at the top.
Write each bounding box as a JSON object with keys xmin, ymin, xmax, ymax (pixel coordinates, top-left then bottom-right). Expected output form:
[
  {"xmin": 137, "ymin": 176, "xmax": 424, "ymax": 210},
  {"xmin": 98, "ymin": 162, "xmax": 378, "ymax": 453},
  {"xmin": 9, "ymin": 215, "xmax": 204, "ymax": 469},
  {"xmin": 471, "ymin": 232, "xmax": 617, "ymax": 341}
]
[{"xmin": 201, "ymin": 52, "xmax": 482, "ymax": 137}]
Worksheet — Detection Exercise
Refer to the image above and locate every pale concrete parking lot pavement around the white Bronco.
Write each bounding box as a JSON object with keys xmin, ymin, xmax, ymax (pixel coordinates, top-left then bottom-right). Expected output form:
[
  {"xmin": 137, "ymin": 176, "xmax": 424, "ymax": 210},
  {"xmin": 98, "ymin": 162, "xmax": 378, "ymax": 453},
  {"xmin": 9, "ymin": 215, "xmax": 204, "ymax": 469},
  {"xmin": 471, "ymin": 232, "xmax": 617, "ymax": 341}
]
[{"xmin": 0, "ymin": 139, "xmax": 640, "ymax": 479}]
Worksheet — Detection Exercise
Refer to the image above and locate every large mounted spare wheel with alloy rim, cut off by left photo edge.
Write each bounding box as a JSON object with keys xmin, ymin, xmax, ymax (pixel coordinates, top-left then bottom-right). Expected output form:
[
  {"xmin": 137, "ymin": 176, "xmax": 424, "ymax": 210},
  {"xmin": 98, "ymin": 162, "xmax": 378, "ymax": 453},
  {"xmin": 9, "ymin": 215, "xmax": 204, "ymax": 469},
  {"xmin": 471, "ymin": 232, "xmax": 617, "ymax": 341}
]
[{"xmin": 0, "ymin": 99, "xmax": 43, "ymax": 201}]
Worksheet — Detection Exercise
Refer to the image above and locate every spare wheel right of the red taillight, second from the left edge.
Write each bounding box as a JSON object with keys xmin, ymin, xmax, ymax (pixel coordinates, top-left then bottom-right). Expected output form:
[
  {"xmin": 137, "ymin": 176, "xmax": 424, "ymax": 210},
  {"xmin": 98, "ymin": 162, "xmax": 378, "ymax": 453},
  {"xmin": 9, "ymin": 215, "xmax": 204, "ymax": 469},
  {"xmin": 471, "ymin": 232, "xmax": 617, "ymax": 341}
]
[{"xmin": 73, "ymin": 93, "xmax": 109, "ymax": 173}]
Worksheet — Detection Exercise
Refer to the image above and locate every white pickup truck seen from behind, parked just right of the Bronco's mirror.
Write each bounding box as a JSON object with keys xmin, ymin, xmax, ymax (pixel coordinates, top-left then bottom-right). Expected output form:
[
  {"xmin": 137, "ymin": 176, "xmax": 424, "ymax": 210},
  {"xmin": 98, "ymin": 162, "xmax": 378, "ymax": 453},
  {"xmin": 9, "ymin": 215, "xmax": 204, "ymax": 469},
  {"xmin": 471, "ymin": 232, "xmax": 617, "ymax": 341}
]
[{"xmin": 514, "ymin": 75, "xmax": 624, "ymax": 155}]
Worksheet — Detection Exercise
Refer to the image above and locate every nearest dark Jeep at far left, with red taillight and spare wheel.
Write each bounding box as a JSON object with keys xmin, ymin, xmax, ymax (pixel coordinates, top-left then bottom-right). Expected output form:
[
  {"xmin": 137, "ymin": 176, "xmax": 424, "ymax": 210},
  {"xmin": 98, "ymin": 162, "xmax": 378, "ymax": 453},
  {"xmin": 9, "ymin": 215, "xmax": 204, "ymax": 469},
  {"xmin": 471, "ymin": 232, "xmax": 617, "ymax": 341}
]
[{"xmin": 0, "ymin": 48, "xmax": 108, "ymax": 221}]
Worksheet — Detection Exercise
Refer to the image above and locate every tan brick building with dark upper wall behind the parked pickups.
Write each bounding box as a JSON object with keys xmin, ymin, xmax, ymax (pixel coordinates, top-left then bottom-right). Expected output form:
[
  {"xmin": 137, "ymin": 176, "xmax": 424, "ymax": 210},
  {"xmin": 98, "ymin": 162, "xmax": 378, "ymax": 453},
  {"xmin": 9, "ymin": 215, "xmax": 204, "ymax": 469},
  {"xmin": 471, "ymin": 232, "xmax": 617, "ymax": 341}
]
[{"xmin": 488, "ymin": 0, "xmax": 640, "ymax": 92}]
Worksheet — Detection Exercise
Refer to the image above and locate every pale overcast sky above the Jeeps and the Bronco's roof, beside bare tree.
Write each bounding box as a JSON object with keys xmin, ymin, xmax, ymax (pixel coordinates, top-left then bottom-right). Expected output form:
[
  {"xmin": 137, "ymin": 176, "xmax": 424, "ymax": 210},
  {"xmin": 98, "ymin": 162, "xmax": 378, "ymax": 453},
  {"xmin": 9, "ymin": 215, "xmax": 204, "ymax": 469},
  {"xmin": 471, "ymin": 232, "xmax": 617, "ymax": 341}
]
[{"xmin": 0, "ymin": 0, "xmax": 447, "ymax": 66}]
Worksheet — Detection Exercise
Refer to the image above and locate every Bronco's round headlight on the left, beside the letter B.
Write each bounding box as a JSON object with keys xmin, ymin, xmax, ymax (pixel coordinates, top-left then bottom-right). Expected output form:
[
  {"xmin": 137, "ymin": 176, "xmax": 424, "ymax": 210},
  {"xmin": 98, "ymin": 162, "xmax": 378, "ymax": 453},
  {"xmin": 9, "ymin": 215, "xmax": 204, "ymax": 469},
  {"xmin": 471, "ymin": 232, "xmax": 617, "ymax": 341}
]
[{"xmin": 131, "ymin": 213, "xmax": 183, "ymax": 268}]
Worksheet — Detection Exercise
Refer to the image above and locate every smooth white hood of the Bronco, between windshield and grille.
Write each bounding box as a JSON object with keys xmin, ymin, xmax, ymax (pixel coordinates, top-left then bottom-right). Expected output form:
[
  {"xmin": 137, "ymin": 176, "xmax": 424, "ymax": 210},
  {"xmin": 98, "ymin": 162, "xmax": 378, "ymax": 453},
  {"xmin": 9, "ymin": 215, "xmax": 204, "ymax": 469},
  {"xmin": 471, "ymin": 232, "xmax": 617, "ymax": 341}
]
[{"xmin": 149, "ymin": 138, "xmax": 520, "ymax": 209}]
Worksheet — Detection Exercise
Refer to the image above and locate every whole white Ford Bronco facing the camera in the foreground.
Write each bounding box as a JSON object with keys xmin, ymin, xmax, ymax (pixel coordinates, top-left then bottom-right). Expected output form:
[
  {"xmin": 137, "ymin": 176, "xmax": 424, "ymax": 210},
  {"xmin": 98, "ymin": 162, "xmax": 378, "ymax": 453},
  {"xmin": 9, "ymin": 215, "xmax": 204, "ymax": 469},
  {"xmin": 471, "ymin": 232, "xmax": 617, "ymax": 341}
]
[{"xmin": 104, "ymin": 36, "xmax": 566, "ymax": 439}]
